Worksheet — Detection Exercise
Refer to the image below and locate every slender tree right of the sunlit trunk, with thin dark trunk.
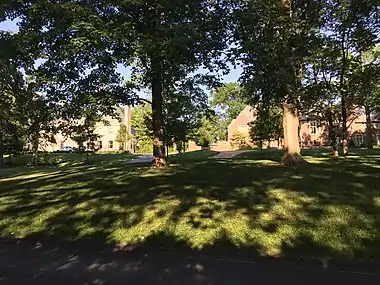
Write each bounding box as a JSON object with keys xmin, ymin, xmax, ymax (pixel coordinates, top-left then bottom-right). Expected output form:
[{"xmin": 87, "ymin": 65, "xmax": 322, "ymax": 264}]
[{"xmin": 321, "ymin": 0, "xmax": 380, "ymax": 155}]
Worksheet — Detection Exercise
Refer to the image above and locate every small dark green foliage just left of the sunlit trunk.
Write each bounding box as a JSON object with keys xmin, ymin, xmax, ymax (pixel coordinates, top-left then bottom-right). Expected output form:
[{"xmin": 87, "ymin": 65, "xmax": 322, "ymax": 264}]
[{"xmin": 249, "ymin": 105, "xmax": 283, "ymax": 149}]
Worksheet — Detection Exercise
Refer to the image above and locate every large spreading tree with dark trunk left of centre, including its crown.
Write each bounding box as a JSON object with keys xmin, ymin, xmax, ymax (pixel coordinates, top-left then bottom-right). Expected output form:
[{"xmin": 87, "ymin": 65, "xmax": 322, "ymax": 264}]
[{"xmin": 0, "ymin": 0, "xmax": 226, "ymax": 166}]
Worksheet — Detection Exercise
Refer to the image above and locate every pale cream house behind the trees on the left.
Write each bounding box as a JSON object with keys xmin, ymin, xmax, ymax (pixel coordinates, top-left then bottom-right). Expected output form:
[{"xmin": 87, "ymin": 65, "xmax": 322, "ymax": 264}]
[{"xmin": 41, "ymin": 106, "xmax": 133, "ymax": 152}]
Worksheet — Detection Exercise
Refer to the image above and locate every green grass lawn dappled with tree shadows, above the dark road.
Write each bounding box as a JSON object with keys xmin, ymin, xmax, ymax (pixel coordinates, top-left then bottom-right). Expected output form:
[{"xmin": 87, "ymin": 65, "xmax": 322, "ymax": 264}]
[{"xmin": 0, "ymin": 150, "xmax": 380, "ymax": 261}]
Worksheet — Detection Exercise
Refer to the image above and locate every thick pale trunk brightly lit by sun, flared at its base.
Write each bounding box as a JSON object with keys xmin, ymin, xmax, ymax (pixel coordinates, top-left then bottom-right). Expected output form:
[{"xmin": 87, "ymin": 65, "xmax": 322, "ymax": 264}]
[{"xmin": 281, "ymin": 103, "xmax": 307, "ymax": 166}]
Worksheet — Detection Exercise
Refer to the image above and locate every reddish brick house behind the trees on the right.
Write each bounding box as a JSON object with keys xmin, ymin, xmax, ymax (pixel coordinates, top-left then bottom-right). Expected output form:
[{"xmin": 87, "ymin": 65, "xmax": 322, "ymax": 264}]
[{"xmin": 228, "ymin": 106, "xmax": 380, "ymax": 148}]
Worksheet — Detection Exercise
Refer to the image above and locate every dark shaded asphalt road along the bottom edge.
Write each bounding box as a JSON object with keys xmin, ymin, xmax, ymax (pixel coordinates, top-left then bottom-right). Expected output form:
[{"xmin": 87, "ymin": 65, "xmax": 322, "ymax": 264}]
[{"xmin": 0, "ymin": 241, "xmax": 380, "ymax": 285}]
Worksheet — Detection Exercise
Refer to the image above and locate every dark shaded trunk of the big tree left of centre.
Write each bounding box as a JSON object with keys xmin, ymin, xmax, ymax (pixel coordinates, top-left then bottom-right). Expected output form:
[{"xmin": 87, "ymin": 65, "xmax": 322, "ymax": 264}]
[{"xmin": 151, "ymin": 56, "xmax": 167, "ymax": 167}]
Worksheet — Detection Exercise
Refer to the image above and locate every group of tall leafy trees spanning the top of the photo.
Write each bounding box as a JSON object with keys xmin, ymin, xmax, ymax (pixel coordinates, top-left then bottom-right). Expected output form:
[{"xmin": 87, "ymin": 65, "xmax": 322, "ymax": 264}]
[{"xmin": 0, "ymin": 0, "xmax": 380, "ymax": 167}]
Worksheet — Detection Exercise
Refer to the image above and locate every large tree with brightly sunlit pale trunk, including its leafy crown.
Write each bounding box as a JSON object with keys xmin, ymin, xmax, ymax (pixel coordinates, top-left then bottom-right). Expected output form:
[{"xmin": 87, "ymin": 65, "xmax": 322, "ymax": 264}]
[{"xmin": 235, "ymin": 0, "xmax": 321, "ymax": 165}]
